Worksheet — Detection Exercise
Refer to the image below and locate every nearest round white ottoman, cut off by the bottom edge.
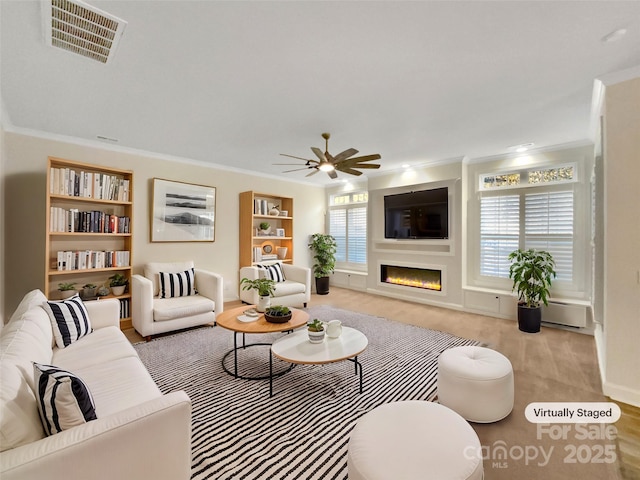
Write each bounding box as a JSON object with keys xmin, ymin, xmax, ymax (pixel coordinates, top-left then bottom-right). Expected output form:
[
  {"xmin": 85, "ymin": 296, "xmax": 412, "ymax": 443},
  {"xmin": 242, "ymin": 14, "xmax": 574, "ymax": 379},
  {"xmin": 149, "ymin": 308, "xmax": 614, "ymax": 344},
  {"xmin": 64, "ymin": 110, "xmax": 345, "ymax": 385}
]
[{"xmin": 347, "ymin": 401, "xmax": 483, "ymax": 480}]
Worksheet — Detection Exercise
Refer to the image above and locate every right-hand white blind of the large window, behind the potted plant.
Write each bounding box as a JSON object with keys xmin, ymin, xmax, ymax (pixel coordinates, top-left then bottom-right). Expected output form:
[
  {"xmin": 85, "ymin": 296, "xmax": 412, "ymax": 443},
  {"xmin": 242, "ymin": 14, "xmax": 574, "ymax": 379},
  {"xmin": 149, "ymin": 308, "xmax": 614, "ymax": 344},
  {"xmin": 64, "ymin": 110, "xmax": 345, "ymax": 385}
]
[{"xmin": 524, "ymin": 191, "xmax": 573, "ymax": 282}]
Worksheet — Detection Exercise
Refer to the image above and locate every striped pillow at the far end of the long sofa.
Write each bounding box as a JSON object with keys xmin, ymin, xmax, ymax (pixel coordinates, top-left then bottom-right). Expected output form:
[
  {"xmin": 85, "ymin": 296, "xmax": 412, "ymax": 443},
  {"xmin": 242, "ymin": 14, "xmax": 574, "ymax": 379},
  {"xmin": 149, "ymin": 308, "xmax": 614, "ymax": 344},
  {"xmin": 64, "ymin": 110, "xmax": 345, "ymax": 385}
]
[{"xmin": 43, "ymin": 294, "xmax": 92, "ymax": 348}]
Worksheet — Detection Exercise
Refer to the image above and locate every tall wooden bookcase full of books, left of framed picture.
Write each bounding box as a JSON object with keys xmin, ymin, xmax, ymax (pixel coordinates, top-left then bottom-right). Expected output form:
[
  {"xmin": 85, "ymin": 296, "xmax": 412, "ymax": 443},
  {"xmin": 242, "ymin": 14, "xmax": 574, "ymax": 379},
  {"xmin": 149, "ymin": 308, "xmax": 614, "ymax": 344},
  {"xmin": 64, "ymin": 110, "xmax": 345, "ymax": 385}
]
[{"xmin": 45, "ymin": 157, "xmax": 133, "ymax": 329}]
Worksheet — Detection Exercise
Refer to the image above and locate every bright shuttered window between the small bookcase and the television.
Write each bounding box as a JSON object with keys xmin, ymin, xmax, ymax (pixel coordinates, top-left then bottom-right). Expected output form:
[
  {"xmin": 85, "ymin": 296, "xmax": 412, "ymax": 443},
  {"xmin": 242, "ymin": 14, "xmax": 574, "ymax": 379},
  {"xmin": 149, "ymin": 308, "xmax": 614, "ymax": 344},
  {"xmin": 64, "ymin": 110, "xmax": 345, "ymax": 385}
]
[{"xmin": 329, "ymin": 192, "xmax": 368, "ymax": 269}]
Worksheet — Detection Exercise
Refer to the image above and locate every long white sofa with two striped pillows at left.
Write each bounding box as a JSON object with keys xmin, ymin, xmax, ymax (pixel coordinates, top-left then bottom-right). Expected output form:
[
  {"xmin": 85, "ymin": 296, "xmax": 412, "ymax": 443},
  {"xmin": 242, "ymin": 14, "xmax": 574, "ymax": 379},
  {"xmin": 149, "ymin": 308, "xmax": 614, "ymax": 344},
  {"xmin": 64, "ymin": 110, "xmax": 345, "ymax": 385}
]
[{"xmin": 0, "ymin": 290, "xmax": 191, "ymax": 480}]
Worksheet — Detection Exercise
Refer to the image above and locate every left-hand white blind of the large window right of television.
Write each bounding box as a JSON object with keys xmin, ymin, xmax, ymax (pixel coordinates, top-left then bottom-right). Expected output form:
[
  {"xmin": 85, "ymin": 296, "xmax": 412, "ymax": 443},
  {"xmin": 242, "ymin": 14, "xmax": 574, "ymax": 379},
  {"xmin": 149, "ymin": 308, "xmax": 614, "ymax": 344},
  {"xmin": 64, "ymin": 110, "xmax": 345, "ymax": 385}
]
[{"xmin": 480, "ymin": 195, "xmax": 520, "ymax": 278}]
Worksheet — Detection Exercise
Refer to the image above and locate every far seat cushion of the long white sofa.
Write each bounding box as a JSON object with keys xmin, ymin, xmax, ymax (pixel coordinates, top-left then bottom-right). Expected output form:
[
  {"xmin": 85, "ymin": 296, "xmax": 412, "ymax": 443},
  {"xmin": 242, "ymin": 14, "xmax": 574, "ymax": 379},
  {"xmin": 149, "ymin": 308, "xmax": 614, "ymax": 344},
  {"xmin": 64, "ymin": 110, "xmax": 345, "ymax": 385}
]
[{"xmin": 51, "ymin": 327, "xmax": 138, "ymax": 373}]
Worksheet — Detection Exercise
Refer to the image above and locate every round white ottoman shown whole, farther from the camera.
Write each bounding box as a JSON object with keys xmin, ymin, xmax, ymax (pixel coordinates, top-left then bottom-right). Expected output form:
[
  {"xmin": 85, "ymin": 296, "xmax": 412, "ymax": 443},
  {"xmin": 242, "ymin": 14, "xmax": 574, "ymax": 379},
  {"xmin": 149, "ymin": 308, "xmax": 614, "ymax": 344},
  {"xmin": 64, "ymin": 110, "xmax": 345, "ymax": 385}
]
[{"xmin": 438, "ymin": 346, "xmax": 513, "ymax": 423}]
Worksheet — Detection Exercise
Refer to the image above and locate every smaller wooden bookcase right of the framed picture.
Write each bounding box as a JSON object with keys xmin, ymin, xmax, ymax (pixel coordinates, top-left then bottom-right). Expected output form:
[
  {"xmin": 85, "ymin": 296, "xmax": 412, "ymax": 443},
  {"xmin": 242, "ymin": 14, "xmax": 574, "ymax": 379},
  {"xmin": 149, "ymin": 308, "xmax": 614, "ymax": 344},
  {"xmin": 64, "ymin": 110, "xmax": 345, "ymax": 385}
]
[{"xmin": 240, "ymin": 191, "xmax": 294, "ymax": 267}]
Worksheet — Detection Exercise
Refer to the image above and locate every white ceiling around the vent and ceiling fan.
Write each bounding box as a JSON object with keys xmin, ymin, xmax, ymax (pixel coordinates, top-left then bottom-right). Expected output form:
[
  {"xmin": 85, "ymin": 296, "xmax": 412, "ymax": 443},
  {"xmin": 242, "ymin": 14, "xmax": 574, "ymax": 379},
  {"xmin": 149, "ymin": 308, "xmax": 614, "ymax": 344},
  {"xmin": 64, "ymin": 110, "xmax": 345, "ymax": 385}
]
[{"xmin": 0, "ymin": 0, "xmax": 640, "ymax": 184}]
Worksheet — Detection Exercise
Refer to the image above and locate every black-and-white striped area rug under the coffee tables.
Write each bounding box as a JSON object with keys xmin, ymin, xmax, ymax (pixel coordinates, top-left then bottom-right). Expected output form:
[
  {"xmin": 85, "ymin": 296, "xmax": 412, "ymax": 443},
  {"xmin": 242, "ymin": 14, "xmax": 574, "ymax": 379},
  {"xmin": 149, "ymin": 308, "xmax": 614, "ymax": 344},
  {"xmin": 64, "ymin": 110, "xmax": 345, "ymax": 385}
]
[{"xmin": 135, "ymin": 306, "xmax": 479, "ymax": 480}]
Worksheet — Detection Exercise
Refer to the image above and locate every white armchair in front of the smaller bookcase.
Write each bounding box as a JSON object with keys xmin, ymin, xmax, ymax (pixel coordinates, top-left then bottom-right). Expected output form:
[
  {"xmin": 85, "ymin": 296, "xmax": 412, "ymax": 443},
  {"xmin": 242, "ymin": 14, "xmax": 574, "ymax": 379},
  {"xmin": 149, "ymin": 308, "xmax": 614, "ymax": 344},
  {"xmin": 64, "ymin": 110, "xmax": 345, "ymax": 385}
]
[{"xmin": 240, "ymin": 263, "xmax": 311, "ymax": 307}]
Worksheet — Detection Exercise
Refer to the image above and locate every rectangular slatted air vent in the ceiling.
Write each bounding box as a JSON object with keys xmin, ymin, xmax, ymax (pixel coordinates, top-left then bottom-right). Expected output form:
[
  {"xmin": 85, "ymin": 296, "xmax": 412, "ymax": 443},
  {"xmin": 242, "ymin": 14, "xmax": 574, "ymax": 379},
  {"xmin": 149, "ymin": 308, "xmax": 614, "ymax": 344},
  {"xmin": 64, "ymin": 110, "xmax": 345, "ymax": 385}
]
[{"xmin": 42, "ymin": 0, "xmax": 127, "ymax": 63}]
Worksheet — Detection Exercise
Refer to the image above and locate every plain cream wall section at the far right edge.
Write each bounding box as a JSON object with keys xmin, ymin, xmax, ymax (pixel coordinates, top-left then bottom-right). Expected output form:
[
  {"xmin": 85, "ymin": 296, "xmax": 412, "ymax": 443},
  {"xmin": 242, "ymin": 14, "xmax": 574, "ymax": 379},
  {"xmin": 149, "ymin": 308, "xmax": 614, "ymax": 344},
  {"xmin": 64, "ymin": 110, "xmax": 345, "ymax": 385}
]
[{"xmin": 598, "ymin": 77, "xmax": 640, "ymax": 406}]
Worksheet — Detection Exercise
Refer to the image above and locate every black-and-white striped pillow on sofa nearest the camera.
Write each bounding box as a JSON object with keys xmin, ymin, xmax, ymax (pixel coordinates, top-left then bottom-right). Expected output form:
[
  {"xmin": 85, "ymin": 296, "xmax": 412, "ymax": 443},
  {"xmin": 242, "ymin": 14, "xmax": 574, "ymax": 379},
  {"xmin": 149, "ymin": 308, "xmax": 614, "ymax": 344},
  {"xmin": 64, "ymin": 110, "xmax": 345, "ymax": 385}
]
[{"xmin": 33, "ymin": 362, "xmax": 98, "ymax": 435}]
